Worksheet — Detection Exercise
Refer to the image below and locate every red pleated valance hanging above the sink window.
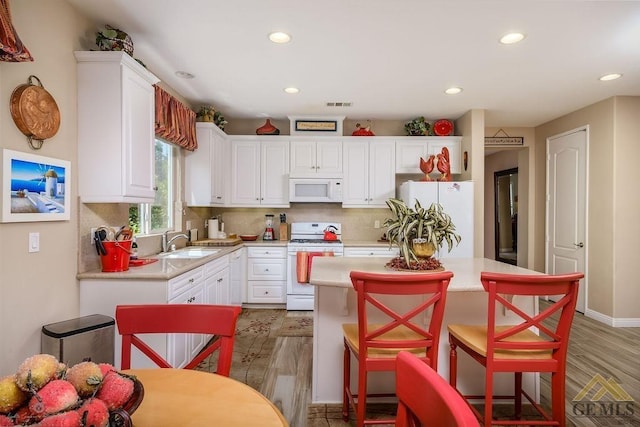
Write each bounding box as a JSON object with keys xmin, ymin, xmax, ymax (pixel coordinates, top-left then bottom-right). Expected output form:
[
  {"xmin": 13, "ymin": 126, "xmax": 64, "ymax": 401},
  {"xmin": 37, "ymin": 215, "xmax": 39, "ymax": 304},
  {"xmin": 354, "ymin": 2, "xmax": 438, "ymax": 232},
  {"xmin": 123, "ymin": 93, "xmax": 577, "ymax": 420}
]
[{"xmin": 154, "ymin": 85, "xmax": 198, "ymax": 151}]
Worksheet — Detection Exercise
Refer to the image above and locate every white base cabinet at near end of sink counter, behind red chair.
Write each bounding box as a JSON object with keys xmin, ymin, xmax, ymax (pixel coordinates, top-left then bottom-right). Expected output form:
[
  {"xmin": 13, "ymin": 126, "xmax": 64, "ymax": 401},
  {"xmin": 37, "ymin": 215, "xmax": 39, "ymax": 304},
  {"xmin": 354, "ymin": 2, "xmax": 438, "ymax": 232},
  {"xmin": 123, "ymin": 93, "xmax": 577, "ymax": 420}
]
[{"xmin": 80, "ymin": 261, "xmax": 209, "ymax": 368}]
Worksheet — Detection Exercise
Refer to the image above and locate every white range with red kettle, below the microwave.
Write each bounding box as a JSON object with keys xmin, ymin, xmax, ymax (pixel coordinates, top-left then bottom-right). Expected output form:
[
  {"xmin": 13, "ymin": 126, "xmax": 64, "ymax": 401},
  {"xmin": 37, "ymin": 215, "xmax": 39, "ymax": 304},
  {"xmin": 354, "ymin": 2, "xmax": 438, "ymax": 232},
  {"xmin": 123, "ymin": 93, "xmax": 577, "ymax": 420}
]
[{"xmin": 287, "ymin": 222, "xmax": 344, "ymax": 310}]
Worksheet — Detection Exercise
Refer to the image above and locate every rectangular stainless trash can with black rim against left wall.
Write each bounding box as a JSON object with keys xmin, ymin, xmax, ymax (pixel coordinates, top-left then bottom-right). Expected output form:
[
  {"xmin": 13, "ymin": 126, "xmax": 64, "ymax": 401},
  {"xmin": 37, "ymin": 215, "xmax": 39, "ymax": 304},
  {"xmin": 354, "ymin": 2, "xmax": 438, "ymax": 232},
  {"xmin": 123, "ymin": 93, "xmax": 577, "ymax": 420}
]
[{"xmin": 41, "ymin": 314, "xmax": 115, "ymax": 366}]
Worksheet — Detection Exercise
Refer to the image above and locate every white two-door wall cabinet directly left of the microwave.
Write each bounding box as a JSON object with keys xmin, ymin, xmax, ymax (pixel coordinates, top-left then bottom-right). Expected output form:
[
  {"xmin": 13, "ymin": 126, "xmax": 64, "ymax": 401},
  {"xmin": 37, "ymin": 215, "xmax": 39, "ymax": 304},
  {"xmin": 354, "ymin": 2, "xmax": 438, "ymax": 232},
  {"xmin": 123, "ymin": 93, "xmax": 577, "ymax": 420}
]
[{"xmin": 231, "ymin": 139, "xmax": 289, "ymax": 207}]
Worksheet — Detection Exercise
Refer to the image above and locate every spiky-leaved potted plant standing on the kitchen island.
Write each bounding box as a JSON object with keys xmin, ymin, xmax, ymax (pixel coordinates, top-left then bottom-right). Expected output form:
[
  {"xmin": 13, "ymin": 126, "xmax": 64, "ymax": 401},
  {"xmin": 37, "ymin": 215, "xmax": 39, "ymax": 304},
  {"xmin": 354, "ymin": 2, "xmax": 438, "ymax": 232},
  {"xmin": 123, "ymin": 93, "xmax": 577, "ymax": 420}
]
[{"xmin": 383, "ymin": 199, "xmax": 461, "ymax": 270}]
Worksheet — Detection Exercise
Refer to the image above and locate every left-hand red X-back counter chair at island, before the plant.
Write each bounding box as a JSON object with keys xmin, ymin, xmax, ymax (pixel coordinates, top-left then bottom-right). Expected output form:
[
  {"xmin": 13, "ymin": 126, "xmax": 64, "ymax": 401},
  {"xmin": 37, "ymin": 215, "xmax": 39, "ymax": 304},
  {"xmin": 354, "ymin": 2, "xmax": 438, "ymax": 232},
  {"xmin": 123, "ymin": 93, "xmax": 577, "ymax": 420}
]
[{"xmin": 342, "ymin": 271, "xmax": 453, "ymax": 427}]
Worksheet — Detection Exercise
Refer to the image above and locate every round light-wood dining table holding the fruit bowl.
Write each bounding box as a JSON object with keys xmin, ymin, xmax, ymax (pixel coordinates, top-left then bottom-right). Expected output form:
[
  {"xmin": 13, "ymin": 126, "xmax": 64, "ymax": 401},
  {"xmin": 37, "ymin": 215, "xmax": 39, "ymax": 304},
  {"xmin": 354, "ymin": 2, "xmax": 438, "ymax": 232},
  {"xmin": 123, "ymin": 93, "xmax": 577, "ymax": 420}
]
[{"xmin": 123, "ymin": 368, "xmax": 289, "ymax": 427}]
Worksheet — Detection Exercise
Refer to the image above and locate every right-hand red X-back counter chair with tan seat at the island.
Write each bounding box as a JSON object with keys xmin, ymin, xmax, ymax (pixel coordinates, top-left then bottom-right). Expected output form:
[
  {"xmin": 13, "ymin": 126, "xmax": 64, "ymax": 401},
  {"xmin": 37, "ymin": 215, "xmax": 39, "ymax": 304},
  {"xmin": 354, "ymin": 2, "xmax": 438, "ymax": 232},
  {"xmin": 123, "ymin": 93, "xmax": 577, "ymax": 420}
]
[{"xmin": 448, "ymin": 272, "xmax": 584, "ymax": 426}]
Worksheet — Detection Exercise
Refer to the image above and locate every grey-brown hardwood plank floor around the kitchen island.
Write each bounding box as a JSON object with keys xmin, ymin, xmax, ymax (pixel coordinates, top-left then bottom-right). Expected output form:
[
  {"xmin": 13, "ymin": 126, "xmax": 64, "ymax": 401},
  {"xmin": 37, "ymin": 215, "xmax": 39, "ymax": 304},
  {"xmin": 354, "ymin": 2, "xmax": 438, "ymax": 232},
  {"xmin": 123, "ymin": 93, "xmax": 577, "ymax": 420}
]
[{"xmin": 261, "ymin": 301, "xmax": 640, "ymax": 427}]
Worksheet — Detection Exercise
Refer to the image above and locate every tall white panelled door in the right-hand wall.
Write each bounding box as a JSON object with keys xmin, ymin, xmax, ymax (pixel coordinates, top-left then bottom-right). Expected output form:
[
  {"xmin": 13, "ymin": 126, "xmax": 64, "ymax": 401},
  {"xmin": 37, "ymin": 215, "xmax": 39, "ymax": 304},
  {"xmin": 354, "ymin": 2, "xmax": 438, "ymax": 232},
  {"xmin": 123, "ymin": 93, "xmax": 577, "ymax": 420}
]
[{"xmin": 546, "ymin": 127, "xmax": 589, "ymax": 313}]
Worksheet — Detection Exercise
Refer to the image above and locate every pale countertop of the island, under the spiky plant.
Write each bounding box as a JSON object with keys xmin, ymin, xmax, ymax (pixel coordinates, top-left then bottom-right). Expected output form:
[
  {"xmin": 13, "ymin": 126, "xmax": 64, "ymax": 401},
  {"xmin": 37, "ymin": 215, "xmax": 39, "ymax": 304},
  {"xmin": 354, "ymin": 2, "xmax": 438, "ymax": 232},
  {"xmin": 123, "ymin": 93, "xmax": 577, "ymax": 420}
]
[{"xmin": 309, "ymin": 257, "xmax": 538, "ymax": 292}]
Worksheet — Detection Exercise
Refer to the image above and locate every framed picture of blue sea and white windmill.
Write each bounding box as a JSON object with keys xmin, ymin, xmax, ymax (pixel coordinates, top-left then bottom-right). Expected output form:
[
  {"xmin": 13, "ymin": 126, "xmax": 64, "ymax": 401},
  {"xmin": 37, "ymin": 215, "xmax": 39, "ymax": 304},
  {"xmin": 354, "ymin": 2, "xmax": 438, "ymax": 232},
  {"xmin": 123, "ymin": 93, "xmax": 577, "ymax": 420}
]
[{"xmin": 2, "ymin": 149, "xmax": 71, "ymax": 222}]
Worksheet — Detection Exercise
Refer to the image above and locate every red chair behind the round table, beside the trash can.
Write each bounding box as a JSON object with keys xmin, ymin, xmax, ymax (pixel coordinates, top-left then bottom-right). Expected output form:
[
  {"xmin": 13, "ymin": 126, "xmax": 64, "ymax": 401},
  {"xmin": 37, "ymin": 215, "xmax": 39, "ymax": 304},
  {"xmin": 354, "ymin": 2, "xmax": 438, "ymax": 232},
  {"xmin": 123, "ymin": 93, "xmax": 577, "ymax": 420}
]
[{"xmin": 116, "ymin": 304, "xmax": 242, "ymax": 377}]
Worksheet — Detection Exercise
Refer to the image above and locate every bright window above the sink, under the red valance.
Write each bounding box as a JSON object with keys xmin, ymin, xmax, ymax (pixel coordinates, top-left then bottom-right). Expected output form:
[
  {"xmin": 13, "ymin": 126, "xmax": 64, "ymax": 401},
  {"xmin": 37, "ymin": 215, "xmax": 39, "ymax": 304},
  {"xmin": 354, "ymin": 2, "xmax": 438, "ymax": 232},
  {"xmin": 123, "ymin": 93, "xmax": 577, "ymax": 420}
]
[{"xmin": 129, "ymin": 139, "xmax": 177, "ymax": 234}]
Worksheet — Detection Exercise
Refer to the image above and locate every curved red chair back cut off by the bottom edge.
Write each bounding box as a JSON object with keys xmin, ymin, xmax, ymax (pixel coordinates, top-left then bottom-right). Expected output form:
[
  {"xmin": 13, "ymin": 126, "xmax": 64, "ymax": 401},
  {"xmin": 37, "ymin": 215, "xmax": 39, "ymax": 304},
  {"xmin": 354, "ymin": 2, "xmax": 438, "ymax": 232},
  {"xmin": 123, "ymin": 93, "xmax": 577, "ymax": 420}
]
[{"xmin": 396, "ymin": 351, "xmax": 479, "ymax": 427}]
